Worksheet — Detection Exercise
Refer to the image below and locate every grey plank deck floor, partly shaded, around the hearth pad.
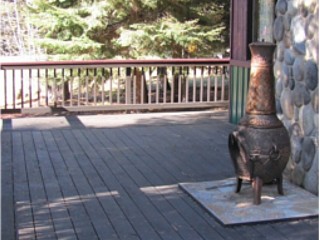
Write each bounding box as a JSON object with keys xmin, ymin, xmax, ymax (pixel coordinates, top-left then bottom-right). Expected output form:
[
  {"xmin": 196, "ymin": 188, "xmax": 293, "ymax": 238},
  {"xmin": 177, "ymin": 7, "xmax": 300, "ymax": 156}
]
[{"xmin": 1, "ymin": 111, "xmax": 319, "ymax": 240}]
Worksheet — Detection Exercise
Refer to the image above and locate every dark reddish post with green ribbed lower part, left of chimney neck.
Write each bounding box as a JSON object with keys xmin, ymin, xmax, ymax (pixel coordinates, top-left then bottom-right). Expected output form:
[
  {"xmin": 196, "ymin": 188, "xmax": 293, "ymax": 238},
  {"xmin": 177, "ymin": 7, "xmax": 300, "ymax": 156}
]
[{"xmin": 229, "ymin": 0, "xmax": 256, "ymax": 124}]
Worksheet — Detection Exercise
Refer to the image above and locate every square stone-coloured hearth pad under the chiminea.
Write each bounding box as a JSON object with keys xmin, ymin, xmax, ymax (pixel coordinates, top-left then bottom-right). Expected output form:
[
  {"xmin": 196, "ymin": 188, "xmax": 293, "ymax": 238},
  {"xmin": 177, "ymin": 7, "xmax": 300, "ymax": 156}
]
[{"xmin": 179, "ymin": 178, "xmax": 319, "ymax": 225}]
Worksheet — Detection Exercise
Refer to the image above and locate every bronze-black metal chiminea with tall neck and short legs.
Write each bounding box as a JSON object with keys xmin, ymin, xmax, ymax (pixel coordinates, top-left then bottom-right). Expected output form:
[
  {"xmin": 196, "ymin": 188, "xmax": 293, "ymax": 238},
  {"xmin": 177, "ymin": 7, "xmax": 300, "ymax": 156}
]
[{"xmin": 229, "ymin": 42, "xmax": 290, "ymax": 205}]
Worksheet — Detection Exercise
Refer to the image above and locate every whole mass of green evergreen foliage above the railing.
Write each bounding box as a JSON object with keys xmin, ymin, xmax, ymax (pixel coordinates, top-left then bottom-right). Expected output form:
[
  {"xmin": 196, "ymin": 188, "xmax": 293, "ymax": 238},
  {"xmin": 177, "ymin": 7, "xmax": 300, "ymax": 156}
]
[{"xmin": 28, "ymin": 0, "xmax": 229, "ymax": 59}]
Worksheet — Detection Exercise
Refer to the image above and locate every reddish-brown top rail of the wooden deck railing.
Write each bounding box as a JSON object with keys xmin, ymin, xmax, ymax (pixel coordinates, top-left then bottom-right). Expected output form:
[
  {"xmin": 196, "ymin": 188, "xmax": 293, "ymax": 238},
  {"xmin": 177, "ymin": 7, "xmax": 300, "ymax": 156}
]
[{"xmin": 0, "ymin": 58, "xmax": 230, "ymax": 70}]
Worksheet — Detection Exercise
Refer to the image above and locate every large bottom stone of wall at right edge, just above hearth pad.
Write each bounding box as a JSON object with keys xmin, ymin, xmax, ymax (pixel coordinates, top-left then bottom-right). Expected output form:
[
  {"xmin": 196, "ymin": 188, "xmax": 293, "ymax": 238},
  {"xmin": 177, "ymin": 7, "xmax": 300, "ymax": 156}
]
[{"xmin": 303, "ymin": 149, "xmax": 319, "ymax": 195}]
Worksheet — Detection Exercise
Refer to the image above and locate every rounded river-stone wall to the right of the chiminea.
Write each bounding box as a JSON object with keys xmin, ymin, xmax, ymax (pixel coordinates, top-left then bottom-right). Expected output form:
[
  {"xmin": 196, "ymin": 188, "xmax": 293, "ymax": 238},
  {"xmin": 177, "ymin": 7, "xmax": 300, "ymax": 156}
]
[{"xmin": 273, "ymin": 0, "xmax": 319, "ymax": 194}]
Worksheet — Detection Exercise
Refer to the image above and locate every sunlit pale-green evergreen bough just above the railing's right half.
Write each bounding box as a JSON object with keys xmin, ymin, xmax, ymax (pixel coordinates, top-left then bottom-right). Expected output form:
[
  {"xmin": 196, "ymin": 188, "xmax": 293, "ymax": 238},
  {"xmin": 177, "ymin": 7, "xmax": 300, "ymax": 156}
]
[{"xmin": 115, "ymin": 17, "xmax": 225, "ymax": 58}]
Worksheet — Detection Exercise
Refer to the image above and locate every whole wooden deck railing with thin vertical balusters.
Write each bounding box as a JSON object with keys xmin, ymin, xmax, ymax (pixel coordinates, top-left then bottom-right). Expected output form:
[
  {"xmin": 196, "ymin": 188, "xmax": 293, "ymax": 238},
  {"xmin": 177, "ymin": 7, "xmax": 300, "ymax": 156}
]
[{"xmin": 0, "ymin": 59, "xmax": 229, "ymax": 112}]
